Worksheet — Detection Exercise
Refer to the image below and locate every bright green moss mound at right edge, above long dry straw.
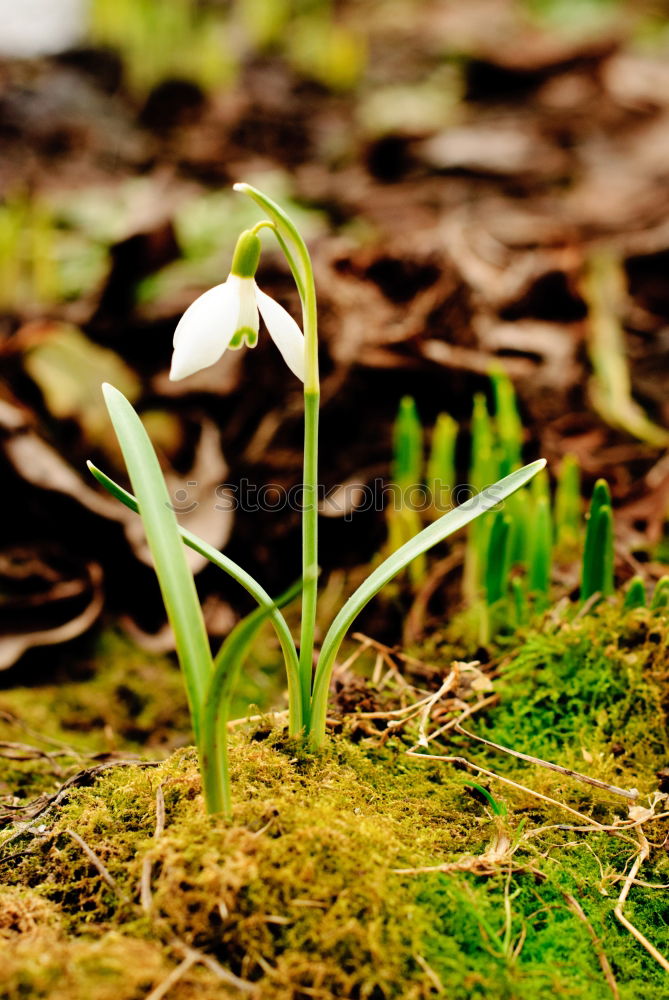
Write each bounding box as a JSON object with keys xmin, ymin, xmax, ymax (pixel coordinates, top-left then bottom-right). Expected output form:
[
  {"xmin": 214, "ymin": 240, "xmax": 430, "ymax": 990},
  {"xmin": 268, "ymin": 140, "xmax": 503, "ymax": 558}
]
[{"xmin": 487, "ymin": 604, "xmax": 669, "ymax": 790}]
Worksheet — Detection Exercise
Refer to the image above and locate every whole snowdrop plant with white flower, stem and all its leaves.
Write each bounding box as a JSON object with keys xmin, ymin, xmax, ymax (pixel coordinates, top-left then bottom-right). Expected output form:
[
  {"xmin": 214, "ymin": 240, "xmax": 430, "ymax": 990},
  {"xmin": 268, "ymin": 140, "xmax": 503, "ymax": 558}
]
[{"xmin": 89, "ymin": 184, "xmax": 545, "ymax": 816}]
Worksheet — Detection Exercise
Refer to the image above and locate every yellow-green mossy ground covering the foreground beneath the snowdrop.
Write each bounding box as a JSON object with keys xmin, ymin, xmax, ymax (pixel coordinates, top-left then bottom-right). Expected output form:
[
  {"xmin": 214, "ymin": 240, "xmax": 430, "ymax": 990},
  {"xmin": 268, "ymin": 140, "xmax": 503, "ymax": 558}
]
[{"xmin": 0, "ymin": 606, "xmax": 669, "ymax": 1000}]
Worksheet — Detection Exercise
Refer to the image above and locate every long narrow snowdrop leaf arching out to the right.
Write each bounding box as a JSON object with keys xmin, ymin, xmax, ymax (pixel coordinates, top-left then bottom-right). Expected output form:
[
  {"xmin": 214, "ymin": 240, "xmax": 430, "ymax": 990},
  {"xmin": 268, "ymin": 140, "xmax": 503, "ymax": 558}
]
[{"xmin": 311, "ymin": 459, "xmax": 546, "ymax": 746}]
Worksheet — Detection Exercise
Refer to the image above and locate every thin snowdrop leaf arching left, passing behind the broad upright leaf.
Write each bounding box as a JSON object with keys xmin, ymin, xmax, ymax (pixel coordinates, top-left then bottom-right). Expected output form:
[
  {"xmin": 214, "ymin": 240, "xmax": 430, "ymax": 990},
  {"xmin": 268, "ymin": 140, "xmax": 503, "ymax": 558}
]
[{"xmin": 88, "ymin": 462, "xmax": 302, "ymax": 736}]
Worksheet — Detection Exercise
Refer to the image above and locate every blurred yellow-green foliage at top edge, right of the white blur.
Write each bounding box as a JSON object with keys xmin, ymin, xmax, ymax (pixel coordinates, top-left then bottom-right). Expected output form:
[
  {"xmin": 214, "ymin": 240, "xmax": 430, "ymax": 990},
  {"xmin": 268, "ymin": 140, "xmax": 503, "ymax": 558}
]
[{"xmin": 90, "ymin": 0, "xmax": 365, "ymax": 94}]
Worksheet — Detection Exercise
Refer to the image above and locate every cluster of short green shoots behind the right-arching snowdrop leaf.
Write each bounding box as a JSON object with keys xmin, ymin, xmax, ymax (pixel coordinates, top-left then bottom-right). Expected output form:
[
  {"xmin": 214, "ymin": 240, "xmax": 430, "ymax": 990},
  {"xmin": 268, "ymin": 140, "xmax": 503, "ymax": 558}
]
[{"xmin": 386, "ymin": 371, "xmax": 669, "ymax": 641}]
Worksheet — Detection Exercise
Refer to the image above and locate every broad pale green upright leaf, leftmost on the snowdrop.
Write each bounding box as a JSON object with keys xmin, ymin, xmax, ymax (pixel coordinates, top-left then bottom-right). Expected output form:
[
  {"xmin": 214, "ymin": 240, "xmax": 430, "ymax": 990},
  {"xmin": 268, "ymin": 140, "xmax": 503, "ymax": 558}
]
[{"xmin": 102, "ymin": 383, "xmax": 213, "ymax": 743}]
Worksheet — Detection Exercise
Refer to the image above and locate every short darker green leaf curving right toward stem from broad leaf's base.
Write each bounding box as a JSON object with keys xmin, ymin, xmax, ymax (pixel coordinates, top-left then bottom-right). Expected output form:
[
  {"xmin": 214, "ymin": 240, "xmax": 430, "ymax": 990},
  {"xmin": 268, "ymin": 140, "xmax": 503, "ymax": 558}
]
[{"xmin": 202, "ymin": 580, "xmax": 302, "ymax": 819}]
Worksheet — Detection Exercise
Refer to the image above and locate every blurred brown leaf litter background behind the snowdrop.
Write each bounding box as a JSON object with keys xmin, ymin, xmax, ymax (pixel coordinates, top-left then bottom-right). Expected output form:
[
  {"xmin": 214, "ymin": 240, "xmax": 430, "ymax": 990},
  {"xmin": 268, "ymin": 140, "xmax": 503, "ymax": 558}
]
[{"xmin": 0, "ymin": 0, "xmax": 669, "ymax": 716}]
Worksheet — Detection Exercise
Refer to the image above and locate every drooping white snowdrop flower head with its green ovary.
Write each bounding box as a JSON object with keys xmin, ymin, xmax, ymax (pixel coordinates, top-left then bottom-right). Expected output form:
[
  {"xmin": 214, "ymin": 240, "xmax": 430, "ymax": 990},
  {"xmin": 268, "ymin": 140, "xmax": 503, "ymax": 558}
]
[{"xmin": 170, "ymin": 229, "xmax": 304, "ymax": 382}]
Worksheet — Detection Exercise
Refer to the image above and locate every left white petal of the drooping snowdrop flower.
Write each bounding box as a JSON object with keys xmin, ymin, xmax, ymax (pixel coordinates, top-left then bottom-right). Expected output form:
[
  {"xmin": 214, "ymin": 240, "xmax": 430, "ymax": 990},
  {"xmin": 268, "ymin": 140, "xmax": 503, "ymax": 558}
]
[{"xmin": 170, "ymin": 275, "xmax": 239, "ymax": 382}]
